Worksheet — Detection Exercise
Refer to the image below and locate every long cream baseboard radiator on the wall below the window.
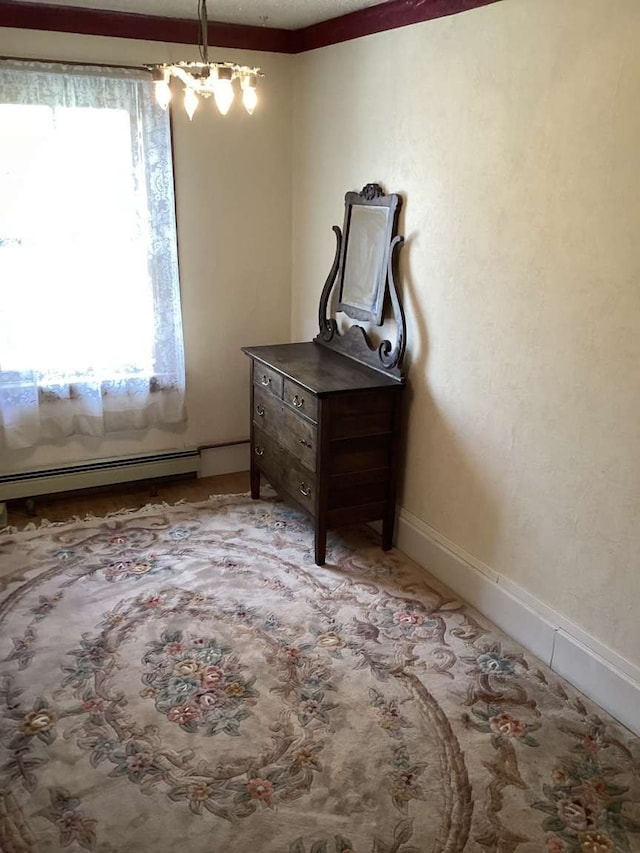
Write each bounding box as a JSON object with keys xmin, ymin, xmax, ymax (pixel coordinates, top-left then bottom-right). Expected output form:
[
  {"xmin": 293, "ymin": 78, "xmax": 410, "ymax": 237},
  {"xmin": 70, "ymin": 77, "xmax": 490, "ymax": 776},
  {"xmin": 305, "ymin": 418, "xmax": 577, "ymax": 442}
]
[{"xmin": 0, "ymin": 448, "xmax": 200, "ymax": 502}]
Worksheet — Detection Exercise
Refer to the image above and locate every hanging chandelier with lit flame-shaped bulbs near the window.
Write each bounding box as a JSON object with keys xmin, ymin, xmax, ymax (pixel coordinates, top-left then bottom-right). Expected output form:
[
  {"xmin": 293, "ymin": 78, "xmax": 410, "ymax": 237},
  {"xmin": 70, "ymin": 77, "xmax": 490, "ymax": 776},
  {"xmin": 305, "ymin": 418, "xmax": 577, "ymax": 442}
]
[{"xmin": 149, "ymin": 0, "xmax": 263, "ymax": 119}]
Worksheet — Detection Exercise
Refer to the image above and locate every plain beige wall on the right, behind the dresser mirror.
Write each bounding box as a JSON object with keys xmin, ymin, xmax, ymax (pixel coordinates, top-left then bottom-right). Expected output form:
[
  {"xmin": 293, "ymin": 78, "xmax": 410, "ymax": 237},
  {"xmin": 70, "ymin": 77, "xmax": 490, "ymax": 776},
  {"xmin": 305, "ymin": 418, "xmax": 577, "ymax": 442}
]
[{"xmin": 292, "ymin": 0, "xmax": 640, "ymax": 665}]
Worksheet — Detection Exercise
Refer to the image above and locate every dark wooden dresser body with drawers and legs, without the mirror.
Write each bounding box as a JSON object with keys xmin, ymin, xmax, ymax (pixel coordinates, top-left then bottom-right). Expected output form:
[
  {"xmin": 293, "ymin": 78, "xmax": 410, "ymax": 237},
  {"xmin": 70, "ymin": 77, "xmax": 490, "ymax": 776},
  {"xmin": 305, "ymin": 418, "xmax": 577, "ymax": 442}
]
[{"xmin": 243, "ymin": 341, "xmax": 404, "ymax": 565}]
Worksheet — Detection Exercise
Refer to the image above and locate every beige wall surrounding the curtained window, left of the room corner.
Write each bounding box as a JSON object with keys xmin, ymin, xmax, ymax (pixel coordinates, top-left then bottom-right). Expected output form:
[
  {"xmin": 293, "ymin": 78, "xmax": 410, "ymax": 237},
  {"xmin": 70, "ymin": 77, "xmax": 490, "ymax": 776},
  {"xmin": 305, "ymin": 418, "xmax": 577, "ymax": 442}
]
[{"xmin": 0, "ymin": 28, "xmax": 293, "ymax": 472}]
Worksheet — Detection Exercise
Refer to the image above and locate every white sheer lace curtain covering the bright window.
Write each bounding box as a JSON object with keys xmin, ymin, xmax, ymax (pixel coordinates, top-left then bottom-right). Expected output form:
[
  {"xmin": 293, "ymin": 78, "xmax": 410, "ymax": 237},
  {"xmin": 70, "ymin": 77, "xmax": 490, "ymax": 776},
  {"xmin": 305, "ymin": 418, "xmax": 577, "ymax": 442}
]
[{"xmin": 0, "ymin": 60, "xmax": 185, "ymax": 448}]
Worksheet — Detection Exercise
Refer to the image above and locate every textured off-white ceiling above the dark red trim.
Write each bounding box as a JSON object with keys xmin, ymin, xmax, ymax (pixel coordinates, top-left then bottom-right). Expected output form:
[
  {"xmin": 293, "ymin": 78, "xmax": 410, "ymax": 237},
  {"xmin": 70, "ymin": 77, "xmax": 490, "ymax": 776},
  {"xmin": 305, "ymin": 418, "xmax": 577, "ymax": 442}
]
[{"xmin": 15, "ymin": 0, "xmax": 388, "ymax": 30}]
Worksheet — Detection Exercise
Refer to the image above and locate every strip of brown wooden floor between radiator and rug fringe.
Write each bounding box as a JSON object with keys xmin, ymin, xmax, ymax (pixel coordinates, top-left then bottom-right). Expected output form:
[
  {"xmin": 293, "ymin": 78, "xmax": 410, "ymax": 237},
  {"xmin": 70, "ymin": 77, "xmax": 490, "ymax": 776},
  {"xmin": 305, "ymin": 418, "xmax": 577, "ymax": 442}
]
[{"xmin": 7, "ymin": 471, "xmax": 249, "ymax": 529}]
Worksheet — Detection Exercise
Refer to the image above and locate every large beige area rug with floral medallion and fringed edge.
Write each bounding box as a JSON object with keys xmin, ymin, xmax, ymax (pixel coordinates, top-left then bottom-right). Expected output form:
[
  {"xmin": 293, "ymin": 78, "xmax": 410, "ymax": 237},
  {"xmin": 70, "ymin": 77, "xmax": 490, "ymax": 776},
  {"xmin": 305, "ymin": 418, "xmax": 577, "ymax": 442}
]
[{"xmin": 0, "ymin": 495, "xmax": 640, "ymax": 853}]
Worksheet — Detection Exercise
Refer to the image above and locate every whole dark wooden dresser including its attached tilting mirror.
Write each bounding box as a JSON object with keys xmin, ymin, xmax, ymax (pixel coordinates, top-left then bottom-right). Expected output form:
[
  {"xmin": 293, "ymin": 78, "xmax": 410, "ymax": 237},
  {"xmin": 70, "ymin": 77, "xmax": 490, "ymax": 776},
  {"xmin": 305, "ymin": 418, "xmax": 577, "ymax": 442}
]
[{"xmin": 243, "ymin": 184, "xmax": 406, "ymax": 565}]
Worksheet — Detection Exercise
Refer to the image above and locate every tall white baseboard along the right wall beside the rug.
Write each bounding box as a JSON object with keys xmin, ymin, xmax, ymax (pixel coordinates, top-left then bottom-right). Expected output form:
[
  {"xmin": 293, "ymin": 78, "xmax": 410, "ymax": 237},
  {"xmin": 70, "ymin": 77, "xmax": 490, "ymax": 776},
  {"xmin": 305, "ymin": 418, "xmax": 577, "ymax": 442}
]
[{"xmin": 396, "ymin": 502, "xmax": 640, "ymax": 734}]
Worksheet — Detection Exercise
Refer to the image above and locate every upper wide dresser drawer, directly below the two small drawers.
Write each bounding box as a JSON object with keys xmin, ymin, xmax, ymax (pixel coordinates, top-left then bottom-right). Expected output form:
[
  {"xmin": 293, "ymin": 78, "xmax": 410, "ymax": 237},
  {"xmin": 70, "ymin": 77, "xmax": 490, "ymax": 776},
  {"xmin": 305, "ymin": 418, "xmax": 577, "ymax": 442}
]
[{"xmin": 253, "ymin": 385, "xmax": 317, "ymax": 471}]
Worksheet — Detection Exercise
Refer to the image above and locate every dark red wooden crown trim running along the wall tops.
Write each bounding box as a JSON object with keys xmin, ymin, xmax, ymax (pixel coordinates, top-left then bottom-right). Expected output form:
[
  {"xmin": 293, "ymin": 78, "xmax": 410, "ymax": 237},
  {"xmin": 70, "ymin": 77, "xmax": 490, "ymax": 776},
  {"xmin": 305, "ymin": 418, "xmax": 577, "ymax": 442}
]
[{"xmin": 0, "ymin": 0, "xmax": 501, "ymax": 53}]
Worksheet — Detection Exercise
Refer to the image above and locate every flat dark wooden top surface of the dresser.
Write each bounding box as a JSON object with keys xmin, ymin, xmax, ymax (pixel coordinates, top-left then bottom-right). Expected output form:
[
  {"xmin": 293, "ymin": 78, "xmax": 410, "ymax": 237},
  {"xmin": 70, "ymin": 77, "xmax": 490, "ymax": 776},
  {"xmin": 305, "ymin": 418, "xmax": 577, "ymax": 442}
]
[{"xmin": 242, "ymin": 341, "xmax": 402, "ymax": 397}]
